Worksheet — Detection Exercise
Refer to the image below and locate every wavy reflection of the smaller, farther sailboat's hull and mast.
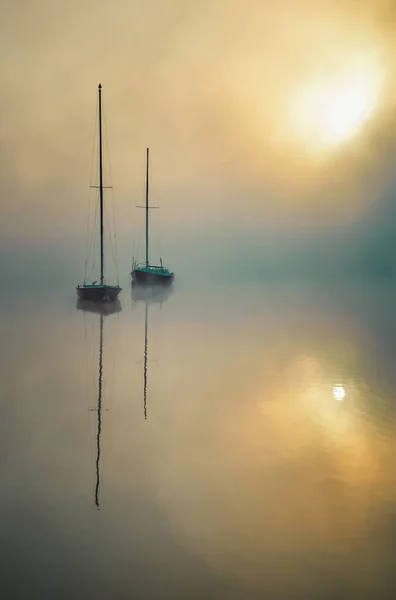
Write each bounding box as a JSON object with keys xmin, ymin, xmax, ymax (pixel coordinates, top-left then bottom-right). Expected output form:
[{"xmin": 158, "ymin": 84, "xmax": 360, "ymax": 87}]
[{"xmin": 131, "ymin": 282, "xmax": 173, "ymax": 419}]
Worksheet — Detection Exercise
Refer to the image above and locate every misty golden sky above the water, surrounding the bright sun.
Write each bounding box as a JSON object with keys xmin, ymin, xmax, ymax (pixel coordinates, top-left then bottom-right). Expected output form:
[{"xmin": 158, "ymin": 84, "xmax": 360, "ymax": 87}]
[{"xmin": 0, "ymin": 0, "xmax": 396, "ymax": 284}]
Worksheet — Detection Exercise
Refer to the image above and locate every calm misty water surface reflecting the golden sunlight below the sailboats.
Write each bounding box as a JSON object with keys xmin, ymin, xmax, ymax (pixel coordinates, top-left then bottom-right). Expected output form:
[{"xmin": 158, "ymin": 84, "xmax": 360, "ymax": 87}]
[{"xmin": 0, "ymin": 282, "xmax": 396, "ymax": 600}]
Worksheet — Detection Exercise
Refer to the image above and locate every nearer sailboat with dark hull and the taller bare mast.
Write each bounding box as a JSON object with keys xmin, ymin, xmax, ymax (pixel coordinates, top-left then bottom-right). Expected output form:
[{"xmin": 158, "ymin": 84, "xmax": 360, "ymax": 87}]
[{"xmin": 76, "ymin": 84, "xmax": 121, "ymax": 302}]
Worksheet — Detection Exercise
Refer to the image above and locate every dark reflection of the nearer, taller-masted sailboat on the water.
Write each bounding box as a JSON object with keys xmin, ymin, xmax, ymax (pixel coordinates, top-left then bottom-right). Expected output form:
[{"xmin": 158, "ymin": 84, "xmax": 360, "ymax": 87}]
[{"xmin": 77, "ymin": 300, "xmax": 122, "ymax": 510}]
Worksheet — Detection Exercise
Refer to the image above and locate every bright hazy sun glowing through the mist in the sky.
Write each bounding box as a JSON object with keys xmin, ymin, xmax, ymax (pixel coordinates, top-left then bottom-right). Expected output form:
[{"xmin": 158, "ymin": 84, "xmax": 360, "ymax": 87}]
[{"xmin": 290, "ymin": 53, "xmax": 383, "ymax": 152}]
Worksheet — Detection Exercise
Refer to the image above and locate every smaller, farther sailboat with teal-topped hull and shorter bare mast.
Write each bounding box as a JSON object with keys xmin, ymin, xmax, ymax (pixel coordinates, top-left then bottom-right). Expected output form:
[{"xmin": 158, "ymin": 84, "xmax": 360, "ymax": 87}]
[{"xmin": 131, "ymin": 148, "xmax": 175, "ymax": 285}]
